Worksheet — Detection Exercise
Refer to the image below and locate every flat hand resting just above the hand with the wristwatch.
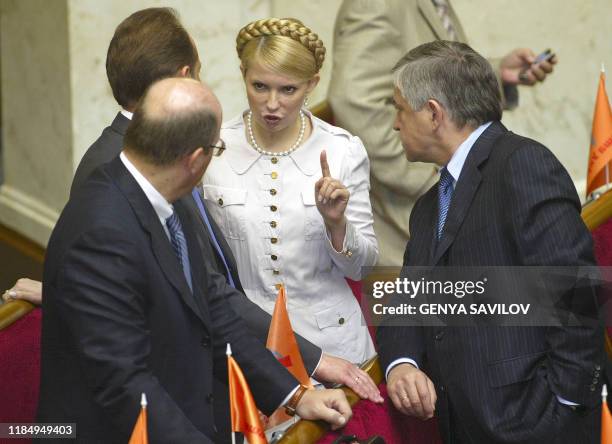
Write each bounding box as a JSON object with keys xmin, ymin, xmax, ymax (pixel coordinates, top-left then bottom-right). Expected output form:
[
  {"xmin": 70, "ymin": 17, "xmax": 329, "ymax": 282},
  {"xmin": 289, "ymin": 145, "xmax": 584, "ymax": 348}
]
[{"xmin": 312, "ymin": 353, "xmax": 384, "ymax": 403}]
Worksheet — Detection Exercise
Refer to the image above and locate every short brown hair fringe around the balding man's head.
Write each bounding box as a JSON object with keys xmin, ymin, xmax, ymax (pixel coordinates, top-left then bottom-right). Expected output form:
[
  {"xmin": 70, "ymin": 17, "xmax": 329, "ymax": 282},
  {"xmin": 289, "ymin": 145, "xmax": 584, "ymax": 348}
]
[{"xmin": 124, "ymin": 92, "xmax": 218, "ymax": 166}]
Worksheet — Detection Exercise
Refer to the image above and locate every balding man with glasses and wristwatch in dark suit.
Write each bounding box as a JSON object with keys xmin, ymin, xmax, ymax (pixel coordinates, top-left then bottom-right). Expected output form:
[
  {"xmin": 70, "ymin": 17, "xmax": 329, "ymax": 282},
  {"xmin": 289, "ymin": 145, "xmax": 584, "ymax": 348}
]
[{"xmin": 38, "ymin": 78, "xmax": 350, "ymax": 443}]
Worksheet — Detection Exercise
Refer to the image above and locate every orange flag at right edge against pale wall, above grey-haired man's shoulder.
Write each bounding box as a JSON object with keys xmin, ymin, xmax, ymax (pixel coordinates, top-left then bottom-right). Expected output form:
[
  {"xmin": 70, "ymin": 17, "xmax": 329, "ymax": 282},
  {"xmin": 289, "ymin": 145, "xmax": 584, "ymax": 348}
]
[{"xmin": 587, "ymin": 70, "xmax": 612, "ymax": 196}]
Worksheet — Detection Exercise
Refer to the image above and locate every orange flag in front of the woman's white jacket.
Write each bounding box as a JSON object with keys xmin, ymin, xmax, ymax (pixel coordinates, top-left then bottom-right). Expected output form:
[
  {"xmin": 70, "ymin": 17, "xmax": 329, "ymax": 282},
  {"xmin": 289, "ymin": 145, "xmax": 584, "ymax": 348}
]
[{"xmin": 266, "ymin": 286, "xmax": 312, "ymax": 428}]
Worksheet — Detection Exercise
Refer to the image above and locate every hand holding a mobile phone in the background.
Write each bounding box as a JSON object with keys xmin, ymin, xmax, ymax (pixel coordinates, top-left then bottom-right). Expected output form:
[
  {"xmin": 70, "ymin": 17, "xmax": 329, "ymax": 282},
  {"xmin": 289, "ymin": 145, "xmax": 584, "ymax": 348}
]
[{"xmin": 499, "ymin": 48, "xmax": 557, "ymax": 86}]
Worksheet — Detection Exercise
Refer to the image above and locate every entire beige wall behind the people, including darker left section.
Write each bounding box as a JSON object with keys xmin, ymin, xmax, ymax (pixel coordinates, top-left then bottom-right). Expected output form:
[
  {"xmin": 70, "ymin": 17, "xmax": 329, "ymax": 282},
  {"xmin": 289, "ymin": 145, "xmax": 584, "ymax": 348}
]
[{"xmin": 0, "ymin": 0, "xmax": 612, "ymax": 244}]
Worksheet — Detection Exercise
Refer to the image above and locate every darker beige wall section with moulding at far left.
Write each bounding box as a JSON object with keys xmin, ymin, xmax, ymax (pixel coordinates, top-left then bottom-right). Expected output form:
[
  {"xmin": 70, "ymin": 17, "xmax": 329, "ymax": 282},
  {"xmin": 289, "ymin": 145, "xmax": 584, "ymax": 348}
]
[{"xmin": 0, "ymin": 0, "xmax": 72, "ymax": 243}]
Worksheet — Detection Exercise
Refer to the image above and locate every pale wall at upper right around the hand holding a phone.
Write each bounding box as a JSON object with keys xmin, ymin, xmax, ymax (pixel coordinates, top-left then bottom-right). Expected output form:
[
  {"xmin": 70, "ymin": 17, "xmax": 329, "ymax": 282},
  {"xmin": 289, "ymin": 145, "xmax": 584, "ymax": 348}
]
[{"xmin": 453, "ymin": 0, "xmax": 612, "ymax": 197}]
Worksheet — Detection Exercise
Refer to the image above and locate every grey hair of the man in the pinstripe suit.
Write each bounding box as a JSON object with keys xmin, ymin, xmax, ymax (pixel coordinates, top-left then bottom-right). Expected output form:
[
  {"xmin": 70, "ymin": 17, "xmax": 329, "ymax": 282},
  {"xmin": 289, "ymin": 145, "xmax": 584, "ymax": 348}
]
[{"xmin": 393, "ymin": 40, "xmax": 502, "ymax": 128}]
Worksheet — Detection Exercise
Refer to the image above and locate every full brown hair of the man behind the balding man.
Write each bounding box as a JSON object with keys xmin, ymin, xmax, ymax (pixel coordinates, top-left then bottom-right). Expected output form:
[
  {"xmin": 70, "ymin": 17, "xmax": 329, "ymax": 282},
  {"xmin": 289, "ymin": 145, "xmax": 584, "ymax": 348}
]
[{"xmin": 106, "ymin": 8, "xmax": 198, "ymax": 108}]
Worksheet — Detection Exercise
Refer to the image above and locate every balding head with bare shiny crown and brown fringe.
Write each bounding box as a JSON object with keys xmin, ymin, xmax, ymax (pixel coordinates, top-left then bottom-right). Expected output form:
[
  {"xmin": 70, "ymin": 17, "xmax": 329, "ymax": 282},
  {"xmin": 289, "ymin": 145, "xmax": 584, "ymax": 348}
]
[{"xmin": 125, "ymin": 78, "xmax": 221, "ymax": 166}]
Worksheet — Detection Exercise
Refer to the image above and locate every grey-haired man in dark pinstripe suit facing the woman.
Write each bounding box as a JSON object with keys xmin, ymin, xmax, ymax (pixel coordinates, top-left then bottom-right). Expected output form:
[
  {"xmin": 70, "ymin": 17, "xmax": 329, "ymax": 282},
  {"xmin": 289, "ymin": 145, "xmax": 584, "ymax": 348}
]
[{"xmin": 378, "ymin": 41, "xmax": 604, "ymax": 444}]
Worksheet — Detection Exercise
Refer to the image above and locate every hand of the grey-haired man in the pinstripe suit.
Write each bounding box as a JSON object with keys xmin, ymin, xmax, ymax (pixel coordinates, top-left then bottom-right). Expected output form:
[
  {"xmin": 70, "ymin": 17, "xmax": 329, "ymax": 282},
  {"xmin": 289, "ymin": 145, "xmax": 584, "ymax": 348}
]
[{"xmin": 387, "ymin": 363, "xmax": 437, "ymax": 419}]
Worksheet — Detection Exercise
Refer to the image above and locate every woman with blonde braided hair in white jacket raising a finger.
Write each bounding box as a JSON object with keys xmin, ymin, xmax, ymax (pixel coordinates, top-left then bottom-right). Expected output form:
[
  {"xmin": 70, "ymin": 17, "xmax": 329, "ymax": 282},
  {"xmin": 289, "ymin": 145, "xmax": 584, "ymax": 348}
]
[{"xmin": 203, "ymin": 18, "xmax": 382, "ymax": 384}]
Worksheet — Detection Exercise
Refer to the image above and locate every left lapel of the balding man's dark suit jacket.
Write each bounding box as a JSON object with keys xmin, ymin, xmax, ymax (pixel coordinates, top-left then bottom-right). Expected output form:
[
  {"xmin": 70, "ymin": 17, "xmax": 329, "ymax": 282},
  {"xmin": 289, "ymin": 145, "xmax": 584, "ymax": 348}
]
[{"xmin": 109, "ymin": 157, "xmax": 207, "ymax": 325}]
